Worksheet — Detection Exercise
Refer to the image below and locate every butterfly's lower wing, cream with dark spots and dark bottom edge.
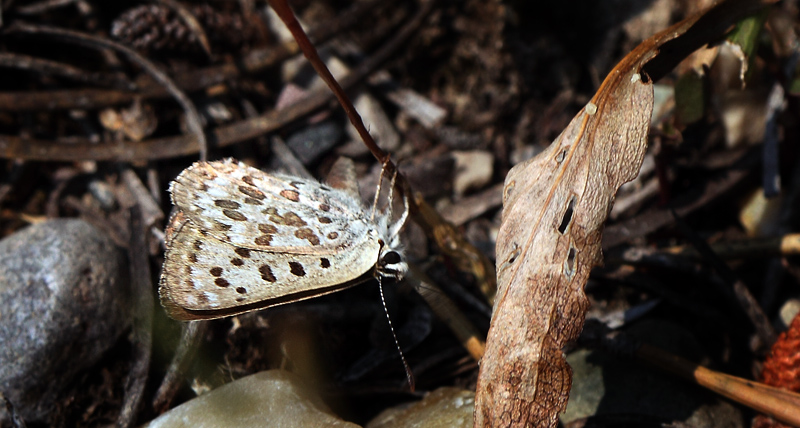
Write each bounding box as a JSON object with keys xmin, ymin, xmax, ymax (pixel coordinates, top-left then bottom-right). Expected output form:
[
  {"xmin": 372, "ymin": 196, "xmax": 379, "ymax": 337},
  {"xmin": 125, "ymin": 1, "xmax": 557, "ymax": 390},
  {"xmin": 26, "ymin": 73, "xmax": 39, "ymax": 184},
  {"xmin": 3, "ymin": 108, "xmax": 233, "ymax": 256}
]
[{"xmin": 159, "ymin": 213, "xmax": 380, "ymax": 320}]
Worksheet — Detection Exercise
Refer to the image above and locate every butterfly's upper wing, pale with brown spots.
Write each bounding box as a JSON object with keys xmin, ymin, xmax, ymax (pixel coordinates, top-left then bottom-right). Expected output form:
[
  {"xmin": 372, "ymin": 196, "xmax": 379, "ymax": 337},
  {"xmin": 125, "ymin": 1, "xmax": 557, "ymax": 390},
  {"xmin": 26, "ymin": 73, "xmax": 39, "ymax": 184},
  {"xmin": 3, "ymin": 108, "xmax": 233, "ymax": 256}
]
[{"xmin": 170, "ymin": 160, "xmax": 370, "ymax": 254}]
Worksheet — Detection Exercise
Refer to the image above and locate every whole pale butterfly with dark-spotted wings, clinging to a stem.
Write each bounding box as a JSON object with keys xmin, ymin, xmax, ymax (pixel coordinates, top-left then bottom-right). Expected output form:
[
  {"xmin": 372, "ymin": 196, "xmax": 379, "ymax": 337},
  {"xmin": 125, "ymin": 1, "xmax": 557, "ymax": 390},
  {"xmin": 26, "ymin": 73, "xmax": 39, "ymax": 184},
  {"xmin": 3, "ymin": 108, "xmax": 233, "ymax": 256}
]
[{"xmin": 159, "ymin": 159, "xmax": 408, "ymax": 320}]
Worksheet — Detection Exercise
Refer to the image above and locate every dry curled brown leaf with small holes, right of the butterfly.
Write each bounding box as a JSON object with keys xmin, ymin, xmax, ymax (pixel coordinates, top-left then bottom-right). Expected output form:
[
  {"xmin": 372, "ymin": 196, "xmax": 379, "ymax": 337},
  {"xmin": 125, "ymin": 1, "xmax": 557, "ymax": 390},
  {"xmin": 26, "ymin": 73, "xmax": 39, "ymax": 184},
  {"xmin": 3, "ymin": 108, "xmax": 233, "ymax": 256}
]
[{"xmin": 474, "ymin": 0, "xmax": 776, "ymax": 427}]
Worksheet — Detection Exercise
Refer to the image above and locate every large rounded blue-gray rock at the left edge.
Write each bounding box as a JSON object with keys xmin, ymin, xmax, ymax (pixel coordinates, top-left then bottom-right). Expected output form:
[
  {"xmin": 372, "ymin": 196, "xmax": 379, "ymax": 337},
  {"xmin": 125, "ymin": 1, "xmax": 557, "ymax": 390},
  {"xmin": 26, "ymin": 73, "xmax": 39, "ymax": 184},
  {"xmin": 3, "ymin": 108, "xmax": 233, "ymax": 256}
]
[{"xmin": 0, "ymin": 219, "xmax": 130, "ymax": 422}]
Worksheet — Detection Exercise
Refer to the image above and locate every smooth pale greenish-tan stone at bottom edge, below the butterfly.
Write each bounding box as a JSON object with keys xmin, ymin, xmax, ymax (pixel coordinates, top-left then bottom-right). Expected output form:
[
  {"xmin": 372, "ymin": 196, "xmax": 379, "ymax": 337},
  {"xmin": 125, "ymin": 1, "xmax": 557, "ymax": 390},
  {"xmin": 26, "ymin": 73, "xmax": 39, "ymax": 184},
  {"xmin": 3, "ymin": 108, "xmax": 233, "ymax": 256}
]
[{"xmin": 145, "ymin": 370, "xmax": 358, "ymax": 428}]
